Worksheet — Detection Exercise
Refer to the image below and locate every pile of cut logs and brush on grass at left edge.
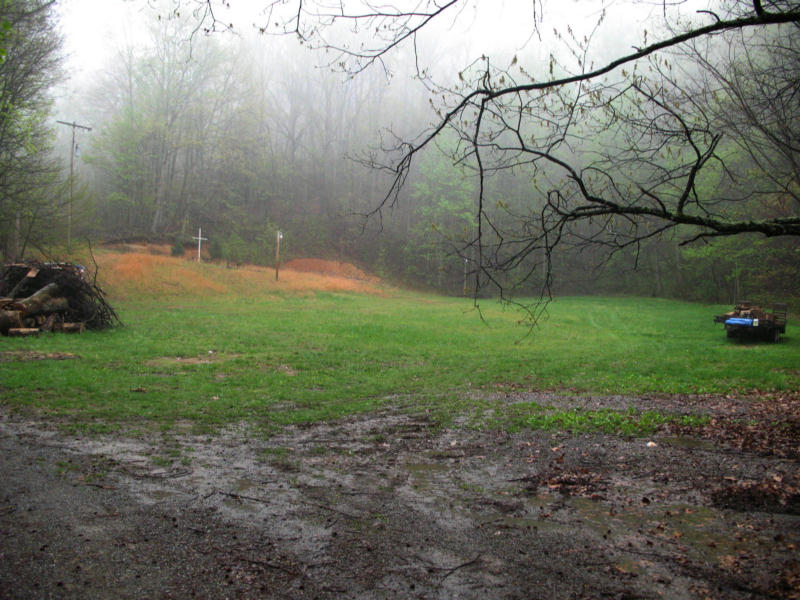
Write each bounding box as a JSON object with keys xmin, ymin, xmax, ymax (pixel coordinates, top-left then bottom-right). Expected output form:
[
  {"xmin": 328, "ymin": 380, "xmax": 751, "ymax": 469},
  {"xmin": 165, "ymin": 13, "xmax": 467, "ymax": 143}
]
[{"xmin": 0, "ymin": 263, "xmax": 120, "ymax": 336}]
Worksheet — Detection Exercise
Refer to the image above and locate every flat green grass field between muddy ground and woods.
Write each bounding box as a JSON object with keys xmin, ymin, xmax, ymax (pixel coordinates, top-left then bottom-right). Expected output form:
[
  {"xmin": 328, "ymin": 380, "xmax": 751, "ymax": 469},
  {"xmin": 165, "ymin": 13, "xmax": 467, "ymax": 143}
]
[{"xmin": 0, "ymin": 292, "xmax": 800, "ymax": 431}]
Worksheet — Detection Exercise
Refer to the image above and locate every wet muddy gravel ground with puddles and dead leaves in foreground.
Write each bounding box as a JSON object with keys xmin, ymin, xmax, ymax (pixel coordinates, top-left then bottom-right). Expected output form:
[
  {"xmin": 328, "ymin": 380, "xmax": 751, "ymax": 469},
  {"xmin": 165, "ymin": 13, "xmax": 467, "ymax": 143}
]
[{"xmin": 0, "ymin": 395, "xmax": 800, "ymax": 599}]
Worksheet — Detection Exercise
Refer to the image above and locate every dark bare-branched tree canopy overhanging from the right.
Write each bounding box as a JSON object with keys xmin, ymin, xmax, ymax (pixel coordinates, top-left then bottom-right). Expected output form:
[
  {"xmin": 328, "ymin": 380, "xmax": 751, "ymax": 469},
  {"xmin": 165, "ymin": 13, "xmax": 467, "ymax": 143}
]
[{"xmin": 158, "ymin": 0, "xmax": 800, "ymax": 300}]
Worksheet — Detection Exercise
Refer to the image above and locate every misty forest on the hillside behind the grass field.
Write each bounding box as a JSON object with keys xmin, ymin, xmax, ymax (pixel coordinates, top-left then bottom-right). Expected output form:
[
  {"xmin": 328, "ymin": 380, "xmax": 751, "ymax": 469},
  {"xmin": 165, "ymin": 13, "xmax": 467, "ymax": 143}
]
[{"xmin": 0, "ymin": 0, "xmax": 800, "ymax": 302}]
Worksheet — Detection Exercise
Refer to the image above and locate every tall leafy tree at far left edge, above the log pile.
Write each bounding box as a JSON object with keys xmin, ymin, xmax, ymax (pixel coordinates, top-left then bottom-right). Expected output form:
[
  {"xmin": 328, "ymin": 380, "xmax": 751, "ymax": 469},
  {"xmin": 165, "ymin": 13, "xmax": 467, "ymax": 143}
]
[{"xmin": 0, "ymin": 0, "xmax": 66, "ymax": 259}]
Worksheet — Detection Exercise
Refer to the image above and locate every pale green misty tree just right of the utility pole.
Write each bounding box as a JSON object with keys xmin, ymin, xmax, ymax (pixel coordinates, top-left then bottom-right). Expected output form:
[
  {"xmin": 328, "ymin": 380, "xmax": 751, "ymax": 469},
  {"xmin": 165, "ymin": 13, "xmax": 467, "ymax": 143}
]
[{"xmin": 88, "ymin": 19, "xmax": 246, "ymax": 235}]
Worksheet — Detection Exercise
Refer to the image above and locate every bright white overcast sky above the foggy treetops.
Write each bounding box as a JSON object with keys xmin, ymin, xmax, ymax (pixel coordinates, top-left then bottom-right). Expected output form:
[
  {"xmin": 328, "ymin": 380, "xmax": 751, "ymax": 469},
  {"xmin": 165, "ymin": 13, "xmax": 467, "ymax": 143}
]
[{"xmin": 51, "ymin": 0, "xmax": 716, "ymax": 120}]
